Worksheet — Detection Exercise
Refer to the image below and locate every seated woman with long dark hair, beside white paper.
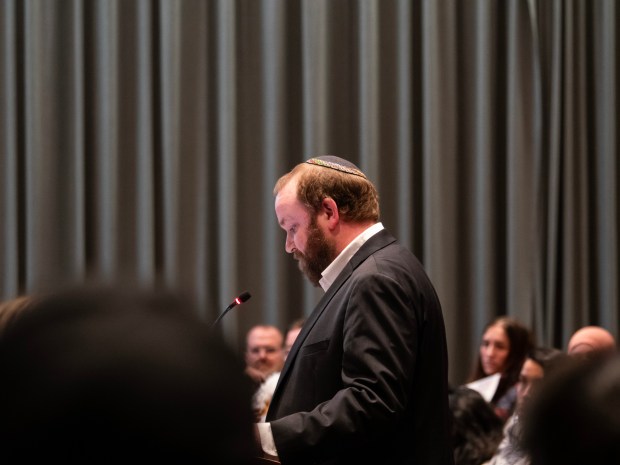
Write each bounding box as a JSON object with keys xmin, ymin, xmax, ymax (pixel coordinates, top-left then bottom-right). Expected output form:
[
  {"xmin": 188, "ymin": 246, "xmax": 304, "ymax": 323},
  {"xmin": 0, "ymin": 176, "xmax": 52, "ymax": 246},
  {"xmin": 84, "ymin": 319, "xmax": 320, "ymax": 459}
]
[{"xmin": 468, "ymin": 317, "xmax": 533, "ymax": 421}]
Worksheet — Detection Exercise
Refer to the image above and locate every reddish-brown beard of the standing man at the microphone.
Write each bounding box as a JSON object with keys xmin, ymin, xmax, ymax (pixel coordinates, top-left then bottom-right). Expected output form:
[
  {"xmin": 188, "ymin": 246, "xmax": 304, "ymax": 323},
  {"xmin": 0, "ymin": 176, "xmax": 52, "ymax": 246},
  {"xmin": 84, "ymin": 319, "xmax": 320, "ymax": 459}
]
[{"xmin": 293, "ymin": 216, "xmax": 336, "ymax": 286}]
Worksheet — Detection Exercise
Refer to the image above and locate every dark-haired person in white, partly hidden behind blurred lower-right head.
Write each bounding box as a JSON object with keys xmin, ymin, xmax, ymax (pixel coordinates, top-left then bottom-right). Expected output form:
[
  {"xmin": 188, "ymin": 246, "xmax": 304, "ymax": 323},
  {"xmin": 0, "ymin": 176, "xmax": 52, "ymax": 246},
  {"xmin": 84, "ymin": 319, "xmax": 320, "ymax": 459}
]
[{"xmin": 489, "ymin": 347, "xmax": 567, "ymax": 465}]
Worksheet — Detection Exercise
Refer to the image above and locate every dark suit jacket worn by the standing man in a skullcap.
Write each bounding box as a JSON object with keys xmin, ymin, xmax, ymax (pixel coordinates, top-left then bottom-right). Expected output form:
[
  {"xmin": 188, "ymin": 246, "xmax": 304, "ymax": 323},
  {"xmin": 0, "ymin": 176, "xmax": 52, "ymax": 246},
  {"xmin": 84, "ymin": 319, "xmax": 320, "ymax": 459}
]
[{"xmin": 266, "ymin": 230, "xmax": 453, "ymax": 465}]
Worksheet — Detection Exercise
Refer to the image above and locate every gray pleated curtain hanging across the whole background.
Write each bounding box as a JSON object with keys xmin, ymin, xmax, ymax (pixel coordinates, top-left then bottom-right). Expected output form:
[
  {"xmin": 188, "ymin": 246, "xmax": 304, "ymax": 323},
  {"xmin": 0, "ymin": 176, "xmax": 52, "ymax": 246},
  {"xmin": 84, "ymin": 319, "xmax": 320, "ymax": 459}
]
[{"xmin": 0, "ymin": 0, "xmax": 620, "ymax": 382}]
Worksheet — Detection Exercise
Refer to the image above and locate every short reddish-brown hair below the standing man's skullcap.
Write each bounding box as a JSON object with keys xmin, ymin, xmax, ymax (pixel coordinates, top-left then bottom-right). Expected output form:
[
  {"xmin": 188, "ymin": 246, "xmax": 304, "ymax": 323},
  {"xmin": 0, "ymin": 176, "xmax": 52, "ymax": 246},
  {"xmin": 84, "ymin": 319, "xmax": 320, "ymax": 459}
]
[{"xmin": 273, "ymin": 163, "xmax": 379, "ymax": 223}]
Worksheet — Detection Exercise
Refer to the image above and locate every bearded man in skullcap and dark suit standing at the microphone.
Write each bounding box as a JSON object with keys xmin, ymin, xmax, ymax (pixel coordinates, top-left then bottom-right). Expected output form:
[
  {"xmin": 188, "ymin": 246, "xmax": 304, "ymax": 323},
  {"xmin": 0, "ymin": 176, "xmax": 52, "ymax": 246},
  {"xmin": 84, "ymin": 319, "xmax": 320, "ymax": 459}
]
[{"xmin": 256, "ymin": 156, "xmax": 453, "ymax": 465}]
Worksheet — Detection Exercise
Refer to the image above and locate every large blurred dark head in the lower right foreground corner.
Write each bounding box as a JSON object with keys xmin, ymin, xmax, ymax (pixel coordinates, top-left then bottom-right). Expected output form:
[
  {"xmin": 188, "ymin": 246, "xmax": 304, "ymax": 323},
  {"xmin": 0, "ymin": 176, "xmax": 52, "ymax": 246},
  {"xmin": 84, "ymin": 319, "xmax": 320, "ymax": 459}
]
[{"xmin": 523, "ymin": 355, "xmax": 620, "ymax": 465}]
